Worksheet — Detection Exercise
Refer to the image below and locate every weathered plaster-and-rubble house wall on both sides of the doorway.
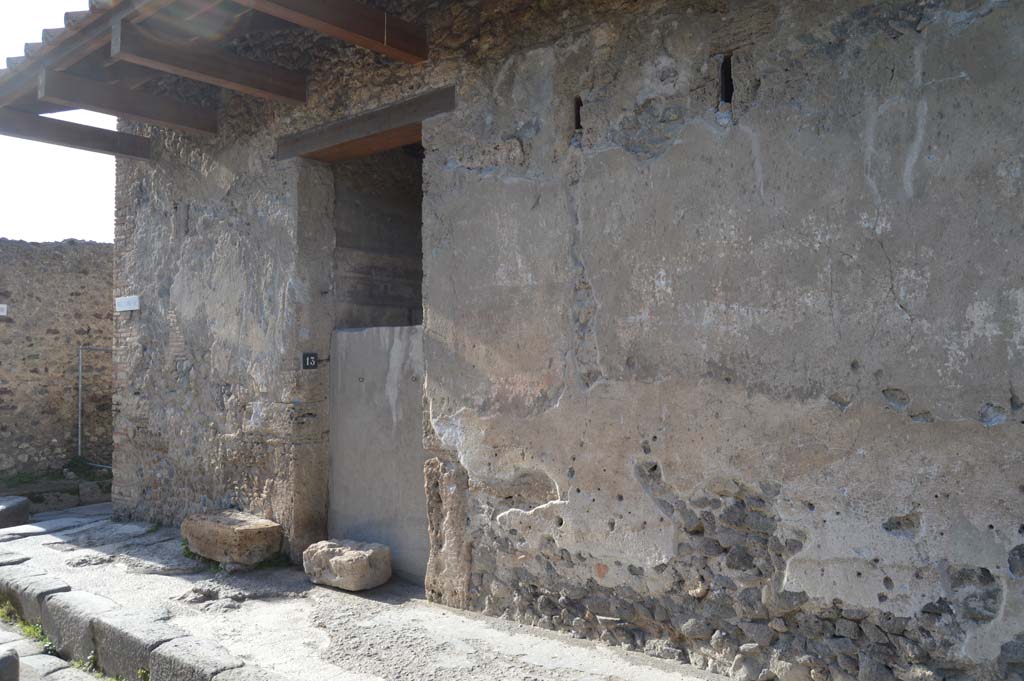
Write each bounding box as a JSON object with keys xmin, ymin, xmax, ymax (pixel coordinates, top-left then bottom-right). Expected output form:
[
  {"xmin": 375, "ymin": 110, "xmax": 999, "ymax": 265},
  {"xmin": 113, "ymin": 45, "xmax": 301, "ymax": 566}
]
[{"xmin": 115, "ymin": 0, "xmax": 1024, "ymax": 681}]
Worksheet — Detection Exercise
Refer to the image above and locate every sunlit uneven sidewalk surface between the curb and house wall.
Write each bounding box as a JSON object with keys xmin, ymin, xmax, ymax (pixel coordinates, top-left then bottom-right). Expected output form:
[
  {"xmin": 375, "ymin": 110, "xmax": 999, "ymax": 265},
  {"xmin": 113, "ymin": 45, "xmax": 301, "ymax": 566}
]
[{"xmin": 0, "ymin": 505, "xmax": 721, "ymax": 681}]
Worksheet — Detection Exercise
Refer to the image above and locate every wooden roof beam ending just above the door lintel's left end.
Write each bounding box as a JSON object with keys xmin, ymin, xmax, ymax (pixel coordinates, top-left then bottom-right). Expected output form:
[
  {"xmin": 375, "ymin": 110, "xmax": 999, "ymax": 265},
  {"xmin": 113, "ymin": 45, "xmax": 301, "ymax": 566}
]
[{"xmin": 111, "ymin": 22, "xmax": 306, "ymax": 103}]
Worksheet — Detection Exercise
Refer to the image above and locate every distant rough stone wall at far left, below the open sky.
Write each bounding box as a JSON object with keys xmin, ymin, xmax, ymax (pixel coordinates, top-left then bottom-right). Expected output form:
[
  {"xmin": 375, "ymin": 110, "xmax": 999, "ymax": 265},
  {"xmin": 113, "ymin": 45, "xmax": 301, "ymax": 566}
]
[{"xmin": 0, "ymin": 239, "xmax": 114, "ymax": 478}]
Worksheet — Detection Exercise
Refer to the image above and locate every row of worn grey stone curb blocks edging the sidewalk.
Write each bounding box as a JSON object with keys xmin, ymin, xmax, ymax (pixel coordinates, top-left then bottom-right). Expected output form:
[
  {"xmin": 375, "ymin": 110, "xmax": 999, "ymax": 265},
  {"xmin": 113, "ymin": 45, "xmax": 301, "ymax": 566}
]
[{"xmin": 0, "ymin": 552, "xmax": 288, "ymax": 681}]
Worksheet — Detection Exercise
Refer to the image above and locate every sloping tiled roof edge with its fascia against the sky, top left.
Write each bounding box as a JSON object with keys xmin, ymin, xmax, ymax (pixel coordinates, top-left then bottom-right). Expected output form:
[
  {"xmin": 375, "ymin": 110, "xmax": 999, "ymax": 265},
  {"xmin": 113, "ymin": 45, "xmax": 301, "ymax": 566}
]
[{"xmin": 0, "ymin": 0, "xmax": 174, "ymax": 107}]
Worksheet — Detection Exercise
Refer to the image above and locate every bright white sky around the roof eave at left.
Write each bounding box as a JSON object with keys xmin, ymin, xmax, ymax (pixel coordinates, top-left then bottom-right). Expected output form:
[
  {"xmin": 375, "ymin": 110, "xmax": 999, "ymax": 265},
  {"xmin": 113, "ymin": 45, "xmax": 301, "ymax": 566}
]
[{"xmin": 0, "ymin": 0, "xmax": 117, "ymax": 242}]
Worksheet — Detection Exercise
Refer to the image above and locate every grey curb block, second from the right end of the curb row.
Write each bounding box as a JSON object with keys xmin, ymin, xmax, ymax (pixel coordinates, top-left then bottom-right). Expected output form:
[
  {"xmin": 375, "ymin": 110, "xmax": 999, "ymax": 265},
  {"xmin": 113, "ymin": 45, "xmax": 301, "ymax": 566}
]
[{"xmin": 92, "ymin": 611, "xmax": 186, "ymax": 681}]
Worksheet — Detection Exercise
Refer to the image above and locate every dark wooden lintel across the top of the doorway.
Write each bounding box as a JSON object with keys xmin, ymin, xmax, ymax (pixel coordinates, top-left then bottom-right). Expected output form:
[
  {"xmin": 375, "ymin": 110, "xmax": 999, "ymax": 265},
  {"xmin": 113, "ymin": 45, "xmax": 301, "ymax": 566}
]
[{"xmin": 276, "ymin": 87, "xmax": 456, "ymax": 160}]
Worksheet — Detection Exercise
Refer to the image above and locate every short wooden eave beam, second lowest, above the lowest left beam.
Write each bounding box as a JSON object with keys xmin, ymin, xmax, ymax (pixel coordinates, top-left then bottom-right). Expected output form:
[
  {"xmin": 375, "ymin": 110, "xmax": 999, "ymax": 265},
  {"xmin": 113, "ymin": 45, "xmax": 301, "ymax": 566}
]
[{"xmin": 39, "ymin": 71, "xmax": 217, "ymax": 134}]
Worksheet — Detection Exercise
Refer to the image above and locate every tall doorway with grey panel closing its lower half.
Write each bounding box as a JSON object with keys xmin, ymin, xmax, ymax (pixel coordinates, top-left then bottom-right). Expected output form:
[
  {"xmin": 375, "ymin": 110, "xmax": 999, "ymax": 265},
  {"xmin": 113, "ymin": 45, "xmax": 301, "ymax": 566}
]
[{"xmin": 328, "ymin": 144, "xmax": 429, "ymax": 584}]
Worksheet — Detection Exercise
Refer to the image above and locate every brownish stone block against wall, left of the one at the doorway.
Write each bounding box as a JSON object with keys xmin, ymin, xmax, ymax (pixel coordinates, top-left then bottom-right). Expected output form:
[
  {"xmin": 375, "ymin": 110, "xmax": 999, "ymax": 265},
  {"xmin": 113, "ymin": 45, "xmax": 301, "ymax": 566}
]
[{"xmin": 181, "ymin": 511, "xmax": 284, "ymax": 565}]
